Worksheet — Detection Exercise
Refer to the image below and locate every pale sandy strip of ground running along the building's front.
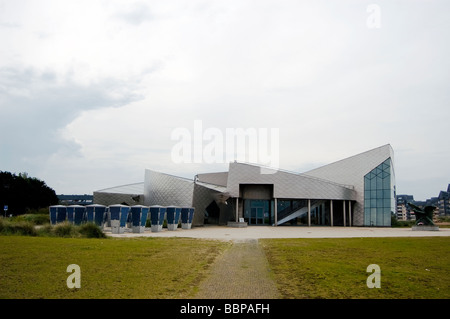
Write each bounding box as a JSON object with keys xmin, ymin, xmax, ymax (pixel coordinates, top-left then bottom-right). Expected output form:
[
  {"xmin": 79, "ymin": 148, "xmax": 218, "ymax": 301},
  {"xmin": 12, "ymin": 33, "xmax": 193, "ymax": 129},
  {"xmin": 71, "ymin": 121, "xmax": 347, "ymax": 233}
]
[{"xmin": 104, "ymin": 226, "xmax": 450, "ymax": 240}]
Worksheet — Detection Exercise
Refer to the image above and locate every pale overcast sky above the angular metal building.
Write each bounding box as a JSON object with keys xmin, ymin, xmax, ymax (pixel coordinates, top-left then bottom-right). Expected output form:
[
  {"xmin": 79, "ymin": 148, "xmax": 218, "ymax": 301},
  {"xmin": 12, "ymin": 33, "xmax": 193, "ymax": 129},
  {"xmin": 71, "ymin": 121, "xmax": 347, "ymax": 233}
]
[{"xmin": 0, "ymin": 0, "xmax": 450, "ymax": 200}]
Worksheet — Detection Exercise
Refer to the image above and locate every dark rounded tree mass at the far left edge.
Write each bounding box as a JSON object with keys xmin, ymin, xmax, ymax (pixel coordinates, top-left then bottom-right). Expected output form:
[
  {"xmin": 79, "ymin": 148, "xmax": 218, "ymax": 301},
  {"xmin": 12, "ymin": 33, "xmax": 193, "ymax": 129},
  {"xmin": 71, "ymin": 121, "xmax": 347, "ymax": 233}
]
[{"xmin": 0, "ymin": 171, "xmax": 58, "ymax": 215}]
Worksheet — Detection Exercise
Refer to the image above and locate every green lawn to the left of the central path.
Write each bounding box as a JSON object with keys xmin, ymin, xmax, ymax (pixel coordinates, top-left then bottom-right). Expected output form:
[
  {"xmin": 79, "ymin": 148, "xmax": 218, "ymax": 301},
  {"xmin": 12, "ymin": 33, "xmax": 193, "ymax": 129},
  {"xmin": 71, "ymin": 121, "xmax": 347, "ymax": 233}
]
[{"xmin": 0, "ymin": 236, "xmax": 228, "ymax": 299}]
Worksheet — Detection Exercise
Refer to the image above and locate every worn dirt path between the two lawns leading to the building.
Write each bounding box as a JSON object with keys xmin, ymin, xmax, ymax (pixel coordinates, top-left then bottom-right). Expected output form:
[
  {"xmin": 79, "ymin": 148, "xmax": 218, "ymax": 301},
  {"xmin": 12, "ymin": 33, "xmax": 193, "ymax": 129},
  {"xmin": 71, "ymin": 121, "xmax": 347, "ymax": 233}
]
[{"xmin": 195, "ymin": 239, "xmax": 280, "ymax": 299}]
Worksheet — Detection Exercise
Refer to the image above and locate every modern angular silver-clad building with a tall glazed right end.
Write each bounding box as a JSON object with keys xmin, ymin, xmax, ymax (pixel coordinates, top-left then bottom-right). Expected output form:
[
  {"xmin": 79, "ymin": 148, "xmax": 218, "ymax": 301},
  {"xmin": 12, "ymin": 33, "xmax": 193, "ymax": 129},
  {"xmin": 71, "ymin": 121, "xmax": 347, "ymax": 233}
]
[{"xmin": 136, "ymin": 144, "xmax": 396, "ymax": 227}]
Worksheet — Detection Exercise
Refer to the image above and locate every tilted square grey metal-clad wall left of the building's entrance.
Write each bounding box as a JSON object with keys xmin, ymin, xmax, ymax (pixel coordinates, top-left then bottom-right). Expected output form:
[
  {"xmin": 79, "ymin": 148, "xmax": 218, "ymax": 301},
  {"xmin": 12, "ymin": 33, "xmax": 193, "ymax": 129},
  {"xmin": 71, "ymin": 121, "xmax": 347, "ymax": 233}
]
[{"xmin": 144, "ymin": 169, "xmax": 195, "ymax": 208}]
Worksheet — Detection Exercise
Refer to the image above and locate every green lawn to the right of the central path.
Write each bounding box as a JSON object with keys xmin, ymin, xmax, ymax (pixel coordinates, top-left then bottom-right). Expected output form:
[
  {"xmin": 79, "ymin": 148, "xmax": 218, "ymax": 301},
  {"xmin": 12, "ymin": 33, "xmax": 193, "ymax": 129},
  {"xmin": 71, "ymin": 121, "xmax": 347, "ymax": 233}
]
[{"xmin": 260, "ymin": 237, "xmax": 450, "ymax": 299}]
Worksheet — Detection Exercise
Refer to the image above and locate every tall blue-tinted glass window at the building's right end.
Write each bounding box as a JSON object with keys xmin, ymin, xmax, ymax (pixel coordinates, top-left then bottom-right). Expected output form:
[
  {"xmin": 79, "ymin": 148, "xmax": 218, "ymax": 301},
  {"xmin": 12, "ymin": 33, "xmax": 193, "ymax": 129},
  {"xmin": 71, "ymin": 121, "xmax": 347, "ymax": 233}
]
[{"xmin": 364, "ymin": 158, "xmax": 395, "ymax": 226}]
